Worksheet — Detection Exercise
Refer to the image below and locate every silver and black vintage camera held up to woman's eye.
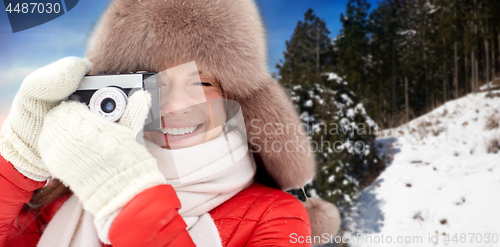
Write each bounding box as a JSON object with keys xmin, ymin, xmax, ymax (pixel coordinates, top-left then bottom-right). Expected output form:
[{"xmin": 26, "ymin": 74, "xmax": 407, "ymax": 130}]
[{"xmin": 69, "ymin": 72, "xmax": 162, "ymax": 131}]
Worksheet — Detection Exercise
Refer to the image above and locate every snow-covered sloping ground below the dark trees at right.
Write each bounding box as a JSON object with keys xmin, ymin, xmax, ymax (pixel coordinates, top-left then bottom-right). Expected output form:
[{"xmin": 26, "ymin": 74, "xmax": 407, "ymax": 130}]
[{"xmin": 343, "ymin": 91, "xmax": 500, "ymax": 247}]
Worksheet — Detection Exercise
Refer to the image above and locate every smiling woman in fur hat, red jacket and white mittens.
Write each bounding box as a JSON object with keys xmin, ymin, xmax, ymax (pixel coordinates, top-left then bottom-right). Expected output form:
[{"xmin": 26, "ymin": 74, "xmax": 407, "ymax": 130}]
[{"xmin": 0, "ymin": 0, "xmax": 338, "ymax": 246}]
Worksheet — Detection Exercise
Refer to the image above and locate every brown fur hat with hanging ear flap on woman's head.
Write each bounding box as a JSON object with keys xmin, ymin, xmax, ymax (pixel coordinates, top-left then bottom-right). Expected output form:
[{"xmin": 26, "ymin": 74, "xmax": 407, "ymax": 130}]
[{"xmin": 87, "ymin": 0, "xmax": 315, "ymax": 189}]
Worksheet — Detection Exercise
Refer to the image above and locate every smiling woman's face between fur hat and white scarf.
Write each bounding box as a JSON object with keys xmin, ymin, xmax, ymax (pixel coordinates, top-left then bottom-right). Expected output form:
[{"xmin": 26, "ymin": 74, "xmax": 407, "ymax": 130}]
[{"xmin": 144, "ymin": 62, "xmax": 226, "ymax": 149}]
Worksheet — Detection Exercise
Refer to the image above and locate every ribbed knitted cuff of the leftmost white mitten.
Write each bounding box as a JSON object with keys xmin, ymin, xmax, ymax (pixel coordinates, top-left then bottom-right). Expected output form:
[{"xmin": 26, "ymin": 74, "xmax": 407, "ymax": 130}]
[{"xmin": 0, "ymin": 119, "xmax": 50, "ymax": 182}]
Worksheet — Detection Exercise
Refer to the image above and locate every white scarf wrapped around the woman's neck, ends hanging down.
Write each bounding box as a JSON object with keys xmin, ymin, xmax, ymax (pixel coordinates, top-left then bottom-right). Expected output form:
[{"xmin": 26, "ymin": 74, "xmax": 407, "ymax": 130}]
[{"xmin": 38, "ymin": 105, "xmax": 256, "ymax": 247}]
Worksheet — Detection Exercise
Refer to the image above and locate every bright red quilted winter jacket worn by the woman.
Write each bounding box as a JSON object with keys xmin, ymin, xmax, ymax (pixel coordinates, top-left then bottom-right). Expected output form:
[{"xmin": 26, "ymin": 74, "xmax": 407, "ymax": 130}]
[{"xmin": 0, "ymin": 153, "xmax": 311, "ymax": 247}]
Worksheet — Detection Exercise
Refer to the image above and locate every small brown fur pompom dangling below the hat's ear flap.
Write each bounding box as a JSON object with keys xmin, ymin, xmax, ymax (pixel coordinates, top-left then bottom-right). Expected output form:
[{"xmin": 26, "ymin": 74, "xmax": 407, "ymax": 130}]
[{"xmin": 304, "ymin": 197, "xmax": 340, "ymax": 239}]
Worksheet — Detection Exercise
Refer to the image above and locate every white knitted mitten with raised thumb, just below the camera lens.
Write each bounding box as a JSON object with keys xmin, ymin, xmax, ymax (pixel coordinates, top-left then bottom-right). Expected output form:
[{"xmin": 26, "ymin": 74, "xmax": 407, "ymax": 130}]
[{"xmin": 39, "ymin": 91, "xmax": 166, "ymax": 240}]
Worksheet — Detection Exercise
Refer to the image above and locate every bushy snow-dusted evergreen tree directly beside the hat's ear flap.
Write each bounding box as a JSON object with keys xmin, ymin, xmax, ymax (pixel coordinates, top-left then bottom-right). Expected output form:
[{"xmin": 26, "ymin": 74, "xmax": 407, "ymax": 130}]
[{"xmin": 288, "ymin": 73, "xmax": 382, "ymax": 205}]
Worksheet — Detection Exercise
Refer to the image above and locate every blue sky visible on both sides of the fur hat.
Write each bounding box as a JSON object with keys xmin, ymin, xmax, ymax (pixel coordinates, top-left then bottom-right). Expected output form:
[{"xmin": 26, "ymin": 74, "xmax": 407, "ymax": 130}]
[{"xmin": 0, "ymin": 0, "xmax": 376, "ymax": 115}]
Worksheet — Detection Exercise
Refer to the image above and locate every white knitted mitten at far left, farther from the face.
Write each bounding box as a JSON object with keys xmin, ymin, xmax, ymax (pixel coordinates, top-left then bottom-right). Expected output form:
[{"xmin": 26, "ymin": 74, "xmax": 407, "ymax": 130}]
[{"xmin": 0, "ymin": 57, "xmax": 92, "ymax": 181}]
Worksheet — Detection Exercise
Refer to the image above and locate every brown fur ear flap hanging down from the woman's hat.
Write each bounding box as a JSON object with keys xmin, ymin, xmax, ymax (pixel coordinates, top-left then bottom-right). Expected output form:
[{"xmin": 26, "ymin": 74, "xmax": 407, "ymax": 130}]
[{"xmin": 236, "ymin": 77, "xmax": 315, "ymax": 190}]
